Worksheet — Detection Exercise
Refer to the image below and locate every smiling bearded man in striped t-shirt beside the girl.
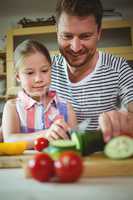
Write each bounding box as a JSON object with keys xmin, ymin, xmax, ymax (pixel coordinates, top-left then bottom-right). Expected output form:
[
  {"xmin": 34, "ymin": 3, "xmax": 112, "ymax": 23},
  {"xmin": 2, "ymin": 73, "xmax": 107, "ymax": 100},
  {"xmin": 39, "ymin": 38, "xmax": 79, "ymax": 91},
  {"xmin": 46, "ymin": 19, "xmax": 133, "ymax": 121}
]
[{"xmin": 52, "ymin": 0, "xmax": 133, "ymax": 141}]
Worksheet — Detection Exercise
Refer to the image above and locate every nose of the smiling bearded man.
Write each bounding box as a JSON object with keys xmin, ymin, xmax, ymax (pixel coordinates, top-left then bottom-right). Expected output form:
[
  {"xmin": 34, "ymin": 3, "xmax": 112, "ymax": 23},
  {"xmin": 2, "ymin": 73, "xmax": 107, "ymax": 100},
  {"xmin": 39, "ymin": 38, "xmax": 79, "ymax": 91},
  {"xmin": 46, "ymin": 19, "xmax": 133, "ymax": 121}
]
[{"xmin": 70, "ymin": 37, "xmax": 82, "ymax": 53}]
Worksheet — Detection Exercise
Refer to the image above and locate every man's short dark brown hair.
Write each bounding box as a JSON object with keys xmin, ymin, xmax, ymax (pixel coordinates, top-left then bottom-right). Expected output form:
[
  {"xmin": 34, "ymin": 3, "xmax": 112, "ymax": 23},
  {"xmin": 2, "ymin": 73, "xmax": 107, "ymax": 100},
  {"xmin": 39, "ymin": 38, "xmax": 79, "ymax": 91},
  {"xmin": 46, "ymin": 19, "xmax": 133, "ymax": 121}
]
[{"xmin": 56, "ymin": 0, "xmax": 103, "ymax": 28}]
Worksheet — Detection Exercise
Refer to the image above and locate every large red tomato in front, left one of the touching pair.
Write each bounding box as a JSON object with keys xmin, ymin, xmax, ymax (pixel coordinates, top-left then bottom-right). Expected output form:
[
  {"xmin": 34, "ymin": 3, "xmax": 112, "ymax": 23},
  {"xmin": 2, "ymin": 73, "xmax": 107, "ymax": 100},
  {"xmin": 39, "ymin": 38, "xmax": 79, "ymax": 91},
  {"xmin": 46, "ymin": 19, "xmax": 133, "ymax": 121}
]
[{"xmin": 28, "ymin": 153, "xmax": 54, "ymax": 182}]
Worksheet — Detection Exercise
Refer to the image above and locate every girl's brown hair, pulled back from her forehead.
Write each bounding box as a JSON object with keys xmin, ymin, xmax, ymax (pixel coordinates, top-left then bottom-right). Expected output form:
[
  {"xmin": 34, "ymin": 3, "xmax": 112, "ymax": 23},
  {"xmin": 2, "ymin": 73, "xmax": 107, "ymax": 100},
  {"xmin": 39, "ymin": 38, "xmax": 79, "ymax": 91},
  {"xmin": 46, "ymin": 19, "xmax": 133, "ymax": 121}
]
[{"xmin": 14, "ymin": 39, "xmax": 51, "ymax": 70}]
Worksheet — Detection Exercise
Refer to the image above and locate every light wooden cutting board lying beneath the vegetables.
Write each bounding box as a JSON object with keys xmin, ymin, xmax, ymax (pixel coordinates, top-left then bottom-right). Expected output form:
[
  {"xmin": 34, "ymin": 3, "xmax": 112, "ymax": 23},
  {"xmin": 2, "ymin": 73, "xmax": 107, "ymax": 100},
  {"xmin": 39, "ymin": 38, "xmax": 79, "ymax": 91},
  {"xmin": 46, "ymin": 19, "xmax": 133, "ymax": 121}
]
[{"xmin": 0, "ymin": 151, "xmax": 133, "ymax": 177}]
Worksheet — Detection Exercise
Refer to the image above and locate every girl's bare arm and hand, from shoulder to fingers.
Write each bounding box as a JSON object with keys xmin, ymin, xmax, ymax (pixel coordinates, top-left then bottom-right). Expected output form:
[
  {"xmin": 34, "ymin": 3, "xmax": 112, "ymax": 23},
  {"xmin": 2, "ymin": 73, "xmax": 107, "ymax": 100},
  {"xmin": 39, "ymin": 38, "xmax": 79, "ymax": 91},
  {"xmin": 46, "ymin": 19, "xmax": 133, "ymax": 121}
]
[{"xmin": 2, "ymin": 100, "xmax": 71, "ymax": 149}]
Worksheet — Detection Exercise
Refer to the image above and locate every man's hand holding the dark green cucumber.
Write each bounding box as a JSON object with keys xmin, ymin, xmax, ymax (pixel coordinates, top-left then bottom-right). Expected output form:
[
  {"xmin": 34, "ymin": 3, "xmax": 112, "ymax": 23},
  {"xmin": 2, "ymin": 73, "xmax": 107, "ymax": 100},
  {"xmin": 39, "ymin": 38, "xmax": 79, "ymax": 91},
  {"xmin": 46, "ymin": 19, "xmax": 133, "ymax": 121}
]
[{"xmin": 99, "ymin": 110, "xmax": 133, "ymax": 142}]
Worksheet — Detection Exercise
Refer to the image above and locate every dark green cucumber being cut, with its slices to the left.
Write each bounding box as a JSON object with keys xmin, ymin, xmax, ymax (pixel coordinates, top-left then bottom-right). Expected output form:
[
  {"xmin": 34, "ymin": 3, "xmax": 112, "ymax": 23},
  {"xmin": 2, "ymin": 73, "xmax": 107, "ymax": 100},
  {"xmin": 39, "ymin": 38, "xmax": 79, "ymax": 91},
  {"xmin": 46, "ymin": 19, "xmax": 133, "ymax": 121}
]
[{"xmin": 44, "ymin": 131, "xmax": 105, "ymax": 159}]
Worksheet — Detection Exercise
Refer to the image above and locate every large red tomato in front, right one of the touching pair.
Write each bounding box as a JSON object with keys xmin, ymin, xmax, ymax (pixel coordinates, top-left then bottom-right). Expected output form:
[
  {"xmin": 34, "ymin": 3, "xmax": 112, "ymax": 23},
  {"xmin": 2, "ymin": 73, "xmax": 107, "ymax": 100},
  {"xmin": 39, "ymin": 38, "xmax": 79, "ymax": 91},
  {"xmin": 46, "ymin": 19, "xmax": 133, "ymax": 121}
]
[{"xmin": 55, "ymin": 151, "xmax": 83, "ymax": 182}]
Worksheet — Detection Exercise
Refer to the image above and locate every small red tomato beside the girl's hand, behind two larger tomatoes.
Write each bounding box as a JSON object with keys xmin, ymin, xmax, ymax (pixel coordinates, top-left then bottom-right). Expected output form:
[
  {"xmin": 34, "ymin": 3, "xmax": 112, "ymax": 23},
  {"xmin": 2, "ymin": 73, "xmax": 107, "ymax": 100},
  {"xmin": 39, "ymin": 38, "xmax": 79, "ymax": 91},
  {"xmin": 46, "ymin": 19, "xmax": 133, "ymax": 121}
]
[{"xmin": 34, "ymin": 137, "xmax": 49, "ymax": 151}]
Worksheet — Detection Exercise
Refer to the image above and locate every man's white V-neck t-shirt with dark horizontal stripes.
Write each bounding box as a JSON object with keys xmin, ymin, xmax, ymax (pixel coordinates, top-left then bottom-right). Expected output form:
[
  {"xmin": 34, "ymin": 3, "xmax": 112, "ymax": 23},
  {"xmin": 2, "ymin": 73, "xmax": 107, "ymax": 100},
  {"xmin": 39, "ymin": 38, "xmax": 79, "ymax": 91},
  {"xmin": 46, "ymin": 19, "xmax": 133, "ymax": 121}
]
[{"xmin": 52, "ymin": 52, "xmax": 133, "ymax": 130}]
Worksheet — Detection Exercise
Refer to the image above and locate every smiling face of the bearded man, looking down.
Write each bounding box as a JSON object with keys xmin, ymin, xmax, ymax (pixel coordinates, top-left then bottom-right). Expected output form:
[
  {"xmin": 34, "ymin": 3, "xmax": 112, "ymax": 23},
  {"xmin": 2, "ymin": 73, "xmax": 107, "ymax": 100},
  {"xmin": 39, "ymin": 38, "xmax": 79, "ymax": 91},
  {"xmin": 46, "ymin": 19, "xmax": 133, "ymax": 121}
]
[{"xmin": 57, "ymin": 13, "xmax": 101, "ymax": 68}]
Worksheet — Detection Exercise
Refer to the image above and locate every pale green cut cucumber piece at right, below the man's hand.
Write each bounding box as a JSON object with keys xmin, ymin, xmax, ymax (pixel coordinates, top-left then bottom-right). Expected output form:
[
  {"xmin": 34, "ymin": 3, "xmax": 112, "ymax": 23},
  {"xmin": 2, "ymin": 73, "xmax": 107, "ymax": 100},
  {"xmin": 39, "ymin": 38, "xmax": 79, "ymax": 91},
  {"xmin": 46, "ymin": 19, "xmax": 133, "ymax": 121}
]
[{"xmin": 104, "ymin": 135, "xmax": 133, "ymax": 159}]
